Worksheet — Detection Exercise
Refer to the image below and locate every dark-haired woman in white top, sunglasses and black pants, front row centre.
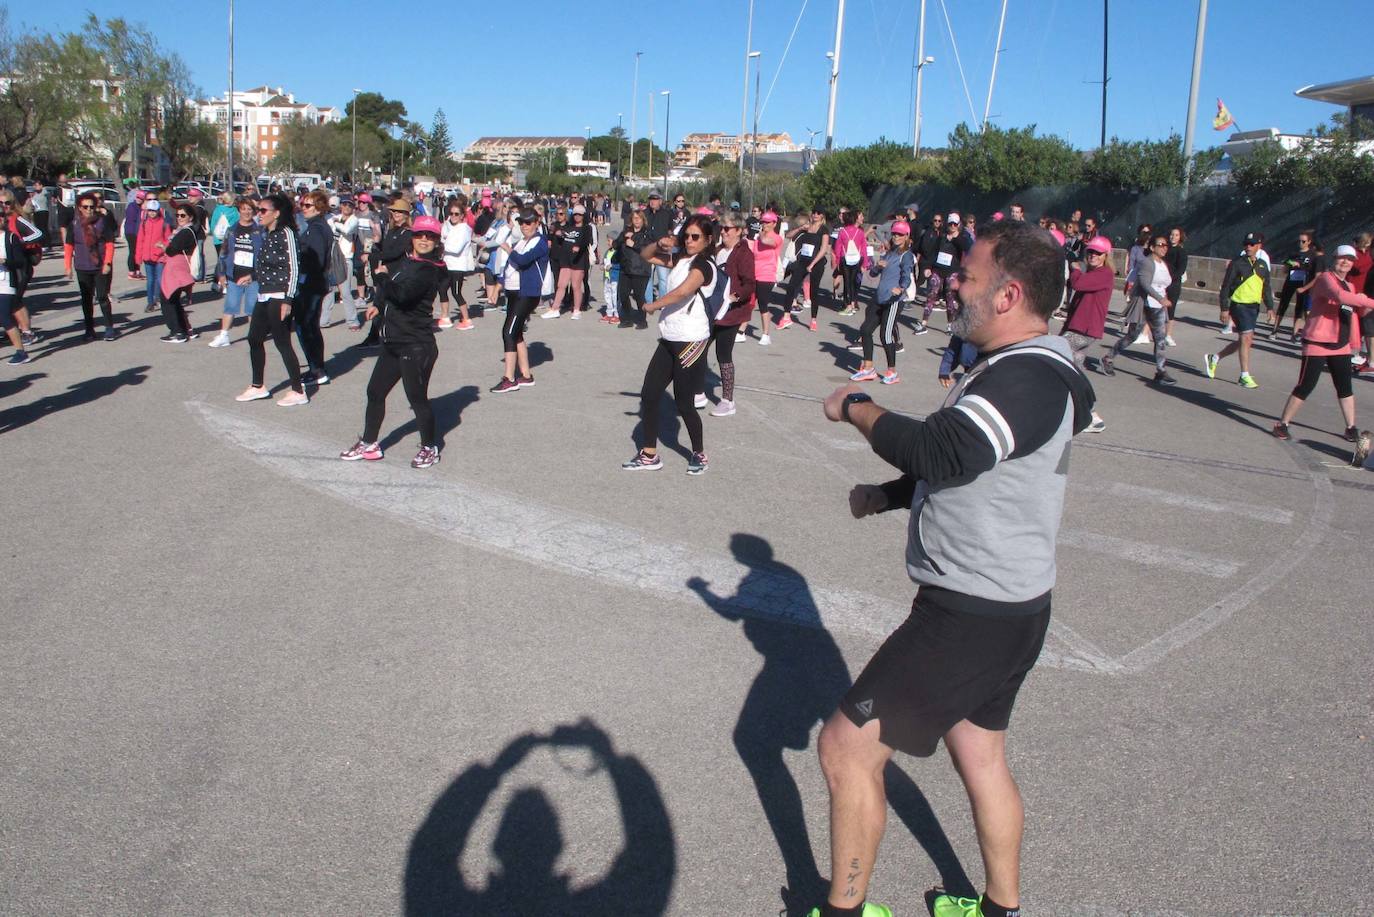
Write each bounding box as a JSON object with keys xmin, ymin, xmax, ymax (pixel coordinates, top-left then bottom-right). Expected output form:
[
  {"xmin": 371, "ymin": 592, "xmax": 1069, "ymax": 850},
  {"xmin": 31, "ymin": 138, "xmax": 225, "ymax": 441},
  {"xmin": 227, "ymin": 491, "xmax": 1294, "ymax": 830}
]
[{"xmin": 621, "ymin": 213, "xmax": 717, "ymax": 474}]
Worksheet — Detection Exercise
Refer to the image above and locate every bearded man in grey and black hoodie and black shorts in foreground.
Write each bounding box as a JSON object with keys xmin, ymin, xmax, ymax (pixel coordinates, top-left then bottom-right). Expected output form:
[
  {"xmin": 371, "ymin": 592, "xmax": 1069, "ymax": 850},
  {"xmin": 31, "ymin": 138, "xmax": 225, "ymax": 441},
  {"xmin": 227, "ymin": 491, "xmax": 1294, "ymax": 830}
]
[{"xmin": 812, "ymin": 220, "xmax": 1094, "ymax": 917}]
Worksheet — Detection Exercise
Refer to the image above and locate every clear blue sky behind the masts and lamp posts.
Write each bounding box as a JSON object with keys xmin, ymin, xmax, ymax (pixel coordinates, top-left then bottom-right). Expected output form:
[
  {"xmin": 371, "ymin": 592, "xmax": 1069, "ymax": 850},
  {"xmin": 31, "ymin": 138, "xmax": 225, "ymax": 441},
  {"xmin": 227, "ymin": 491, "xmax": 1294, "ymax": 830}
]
[{"xmin": 29, "ymin": 0, "xmax": 1371, "ymax": 147}]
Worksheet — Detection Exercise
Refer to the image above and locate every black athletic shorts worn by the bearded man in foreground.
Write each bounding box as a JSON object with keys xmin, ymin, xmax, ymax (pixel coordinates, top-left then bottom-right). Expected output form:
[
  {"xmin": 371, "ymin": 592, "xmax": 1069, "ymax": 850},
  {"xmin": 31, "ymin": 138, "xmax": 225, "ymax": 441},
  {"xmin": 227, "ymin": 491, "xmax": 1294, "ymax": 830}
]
[{"xmin": 840, "ymin": 587, "xmax": 1050, "ymax": 758}]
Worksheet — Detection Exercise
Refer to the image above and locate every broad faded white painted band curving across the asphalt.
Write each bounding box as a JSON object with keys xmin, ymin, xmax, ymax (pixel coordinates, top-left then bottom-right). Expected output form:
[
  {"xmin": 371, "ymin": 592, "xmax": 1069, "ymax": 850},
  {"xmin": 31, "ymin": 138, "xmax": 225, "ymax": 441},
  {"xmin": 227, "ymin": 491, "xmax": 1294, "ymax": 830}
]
[{"xmin": 187, "ymin": 401, "xmax": 1112, "ymax": 671}]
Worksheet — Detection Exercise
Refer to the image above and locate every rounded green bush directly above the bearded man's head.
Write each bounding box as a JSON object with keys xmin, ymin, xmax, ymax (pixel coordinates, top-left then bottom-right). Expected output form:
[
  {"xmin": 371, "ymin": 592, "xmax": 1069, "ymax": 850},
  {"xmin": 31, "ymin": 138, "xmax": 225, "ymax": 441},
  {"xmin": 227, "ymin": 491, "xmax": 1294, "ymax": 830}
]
[{"xmin": 943, "ymin": 124, "xmax": 1081, "ymax": 191}]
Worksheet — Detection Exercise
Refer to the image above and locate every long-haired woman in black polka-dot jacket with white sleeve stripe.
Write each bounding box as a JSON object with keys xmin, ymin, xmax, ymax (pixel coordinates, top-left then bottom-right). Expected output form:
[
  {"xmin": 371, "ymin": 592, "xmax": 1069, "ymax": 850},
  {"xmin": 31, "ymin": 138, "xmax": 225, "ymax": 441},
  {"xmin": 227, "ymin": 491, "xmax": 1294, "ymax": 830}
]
[{"xmin": 234, "ymin": 192, "xmax": 311, "ymax": 407}]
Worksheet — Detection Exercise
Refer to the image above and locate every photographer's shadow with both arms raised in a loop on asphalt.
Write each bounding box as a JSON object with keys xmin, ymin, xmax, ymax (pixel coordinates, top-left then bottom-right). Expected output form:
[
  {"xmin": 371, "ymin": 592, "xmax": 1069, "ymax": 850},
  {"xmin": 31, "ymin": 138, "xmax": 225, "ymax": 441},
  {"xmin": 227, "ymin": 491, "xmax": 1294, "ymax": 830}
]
[{"xmin": 405, "ymin": 719, "xmax": 677, "ymax": 917}]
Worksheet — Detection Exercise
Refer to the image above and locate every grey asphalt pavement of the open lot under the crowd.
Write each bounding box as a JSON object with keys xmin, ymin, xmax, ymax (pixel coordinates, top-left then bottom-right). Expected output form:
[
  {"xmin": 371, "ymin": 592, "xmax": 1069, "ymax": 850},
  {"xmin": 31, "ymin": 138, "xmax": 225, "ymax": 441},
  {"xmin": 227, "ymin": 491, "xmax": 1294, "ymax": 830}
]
[{"xmin": 0, "ymin": 239, "xmax": 1374, "ymax": 917}]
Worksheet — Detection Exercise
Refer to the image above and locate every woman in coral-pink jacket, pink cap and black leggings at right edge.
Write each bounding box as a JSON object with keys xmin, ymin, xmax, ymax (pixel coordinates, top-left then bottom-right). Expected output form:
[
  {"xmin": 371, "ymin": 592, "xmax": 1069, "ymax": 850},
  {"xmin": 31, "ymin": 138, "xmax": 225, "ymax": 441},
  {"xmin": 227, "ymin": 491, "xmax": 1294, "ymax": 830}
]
[{"xmin": 1274, "ymin": 245, "xmax": 1374, "ymax": 443}]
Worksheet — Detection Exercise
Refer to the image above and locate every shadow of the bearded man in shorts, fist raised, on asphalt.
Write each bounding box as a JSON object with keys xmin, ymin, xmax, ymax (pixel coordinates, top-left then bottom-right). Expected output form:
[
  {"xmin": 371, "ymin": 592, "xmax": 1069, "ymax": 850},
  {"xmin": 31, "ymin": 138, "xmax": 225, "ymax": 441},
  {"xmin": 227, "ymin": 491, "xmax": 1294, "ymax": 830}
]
[{"xmin": 687, "ymin": 532, "xmax": 976, "ymax": 916}]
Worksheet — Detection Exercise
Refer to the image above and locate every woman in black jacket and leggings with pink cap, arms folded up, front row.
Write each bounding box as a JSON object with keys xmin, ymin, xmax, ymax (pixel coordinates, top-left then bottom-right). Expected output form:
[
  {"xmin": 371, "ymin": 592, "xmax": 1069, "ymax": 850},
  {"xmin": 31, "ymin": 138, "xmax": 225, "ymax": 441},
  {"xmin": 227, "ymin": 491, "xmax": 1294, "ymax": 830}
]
[{"xmin": 339, "ymin": 216, "xmax": 448, "ymax": 467}]
